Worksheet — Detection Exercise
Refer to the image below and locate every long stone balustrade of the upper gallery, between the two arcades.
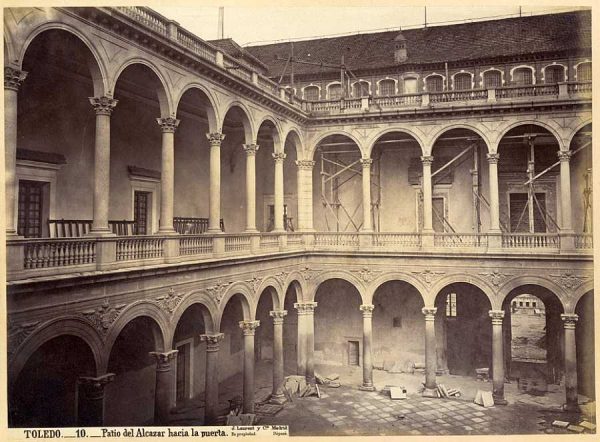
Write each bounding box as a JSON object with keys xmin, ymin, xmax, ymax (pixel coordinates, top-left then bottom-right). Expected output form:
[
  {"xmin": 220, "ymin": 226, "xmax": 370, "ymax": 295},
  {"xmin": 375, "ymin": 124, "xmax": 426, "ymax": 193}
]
[{"xmin": 7, "ymin": 232, "xmax": 593, "ymax": 281}]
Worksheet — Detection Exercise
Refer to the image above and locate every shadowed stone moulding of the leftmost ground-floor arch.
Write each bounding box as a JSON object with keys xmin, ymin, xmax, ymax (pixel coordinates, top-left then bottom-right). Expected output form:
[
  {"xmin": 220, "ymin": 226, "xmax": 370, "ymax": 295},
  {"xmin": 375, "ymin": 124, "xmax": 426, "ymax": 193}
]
[{"xmin": 8, "ymin": 317, "xmax": 108, "ymax": 385}]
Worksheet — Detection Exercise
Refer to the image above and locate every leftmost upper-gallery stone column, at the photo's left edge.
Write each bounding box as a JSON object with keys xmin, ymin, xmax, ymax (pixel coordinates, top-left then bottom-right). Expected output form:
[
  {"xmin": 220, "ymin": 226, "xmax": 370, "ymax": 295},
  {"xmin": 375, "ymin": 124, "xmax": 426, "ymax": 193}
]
[{"xmin": 4, "ymin": 67, "xmax": 27, "ymax": 237}]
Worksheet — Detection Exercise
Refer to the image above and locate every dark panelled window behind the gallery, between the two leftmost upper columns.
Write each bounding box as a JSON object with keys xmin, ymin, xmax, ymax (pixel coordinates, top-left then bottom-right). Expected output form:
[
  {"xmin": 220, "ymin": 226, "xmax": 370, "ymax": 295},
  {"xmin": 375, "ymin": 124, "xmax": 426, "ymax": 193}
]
[{"xmin": 17, "ymin": 180, "xmax": 48, "ymax": 238}]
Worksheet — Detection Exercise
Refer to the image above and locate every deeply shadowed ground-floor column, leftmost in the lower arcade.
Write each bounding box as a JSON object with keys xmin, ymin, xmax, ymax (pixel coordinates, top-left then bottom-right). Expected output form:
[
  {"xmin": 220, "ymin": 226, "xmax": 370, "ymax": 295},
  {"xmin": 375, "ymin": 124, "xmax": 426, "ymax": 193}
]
[{"xmin": 77, "ymin": 373, "xmax": 115, "ymax": 427}]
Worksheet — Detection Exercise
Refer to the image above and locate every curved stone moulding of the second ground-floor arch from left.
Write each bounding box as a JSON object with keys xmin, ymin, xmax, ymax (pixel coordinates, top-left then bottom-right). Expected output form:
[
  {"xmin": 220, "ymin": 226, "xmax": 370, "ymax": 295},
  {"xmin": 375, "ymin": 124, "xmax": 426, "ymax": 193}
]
[{"xmin": 105, "ymin": 300, "xmax": 173, "ymax": 364}]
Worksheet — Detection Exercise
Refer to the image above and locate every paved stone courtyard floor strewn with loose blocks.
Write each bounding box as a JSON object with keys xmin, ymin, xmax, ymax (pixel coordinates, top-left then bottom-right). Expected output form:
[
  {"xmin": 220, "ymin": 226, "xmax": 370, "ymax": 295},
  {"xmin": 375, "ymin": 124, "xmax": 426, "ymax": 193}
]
[{"xmin": 173, "ymin": 363, "xmax": 595, "ymax": 436}]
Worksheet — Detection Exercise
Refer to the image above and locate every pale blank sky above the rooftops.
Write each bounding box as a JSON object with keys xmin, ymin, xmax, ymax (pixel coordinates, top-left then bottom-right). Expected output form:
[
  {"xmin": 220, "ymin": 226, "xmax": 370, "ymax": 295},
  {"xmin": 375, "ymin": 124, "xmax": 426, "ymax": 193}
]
[{"xmin": 152, "ymin": 2, "xmax": 588, "ymax": 45}]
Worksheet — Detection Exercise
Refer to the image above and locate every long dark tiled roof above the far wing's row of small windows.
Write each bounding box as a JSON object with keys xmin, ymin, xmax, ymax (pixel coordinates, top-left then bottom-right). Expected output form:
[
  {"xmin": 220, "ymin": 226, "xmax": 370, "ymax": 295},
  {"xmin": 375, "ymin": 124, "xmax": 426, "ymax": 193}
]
[{"xmin": 246, "ymin": 10, "xmax": 592, "ymax": 76}]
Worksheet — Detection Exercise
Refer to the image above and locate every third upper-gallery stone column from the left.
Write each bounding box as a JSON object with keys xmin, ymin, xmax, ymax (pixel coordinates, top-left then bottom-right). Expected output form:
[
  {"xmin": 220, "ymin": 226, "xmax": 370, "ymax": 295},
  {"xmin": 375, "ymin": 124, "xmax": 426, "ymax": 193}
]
[{"xmin": 156, "ymin": 117, "xmax": 179, "ymax": 234}]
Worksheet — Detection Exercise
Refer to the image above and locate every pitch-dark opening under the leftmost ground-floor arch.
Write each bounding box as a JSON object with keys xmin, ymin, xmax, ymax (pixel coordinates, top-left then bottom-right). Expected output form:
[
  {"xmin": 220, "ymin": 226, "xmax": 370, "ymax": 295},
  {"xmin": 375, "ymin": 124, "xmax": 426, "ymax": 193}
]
[{"xmin": 8, "ymin": 335, "xmax": 96, "ymax": 428}]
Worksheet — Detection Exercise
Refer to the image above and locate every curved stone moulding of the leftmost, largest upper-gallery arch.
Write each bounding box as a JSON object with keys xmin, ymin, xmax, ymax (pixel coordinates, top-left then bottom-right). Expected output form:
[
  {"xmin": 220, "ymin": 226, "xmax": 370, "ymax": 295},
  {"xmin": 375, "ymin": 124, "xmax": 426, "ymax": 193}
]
[{"xmin": 19, "ymin": 22, "xmax": 112, "ymax": 97}]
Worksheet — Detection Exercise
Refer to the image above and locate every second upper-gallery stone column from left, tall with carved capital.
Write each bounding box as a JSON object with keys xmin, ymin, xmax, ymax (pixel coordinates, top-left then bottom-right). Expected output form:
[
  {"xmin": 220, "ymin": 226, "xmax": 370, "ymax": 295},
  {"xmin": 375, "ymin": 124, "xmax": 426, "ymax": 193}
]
[{"xmin": 89, "ymin": 97, "xmax": 118, "ymax": 236}]
